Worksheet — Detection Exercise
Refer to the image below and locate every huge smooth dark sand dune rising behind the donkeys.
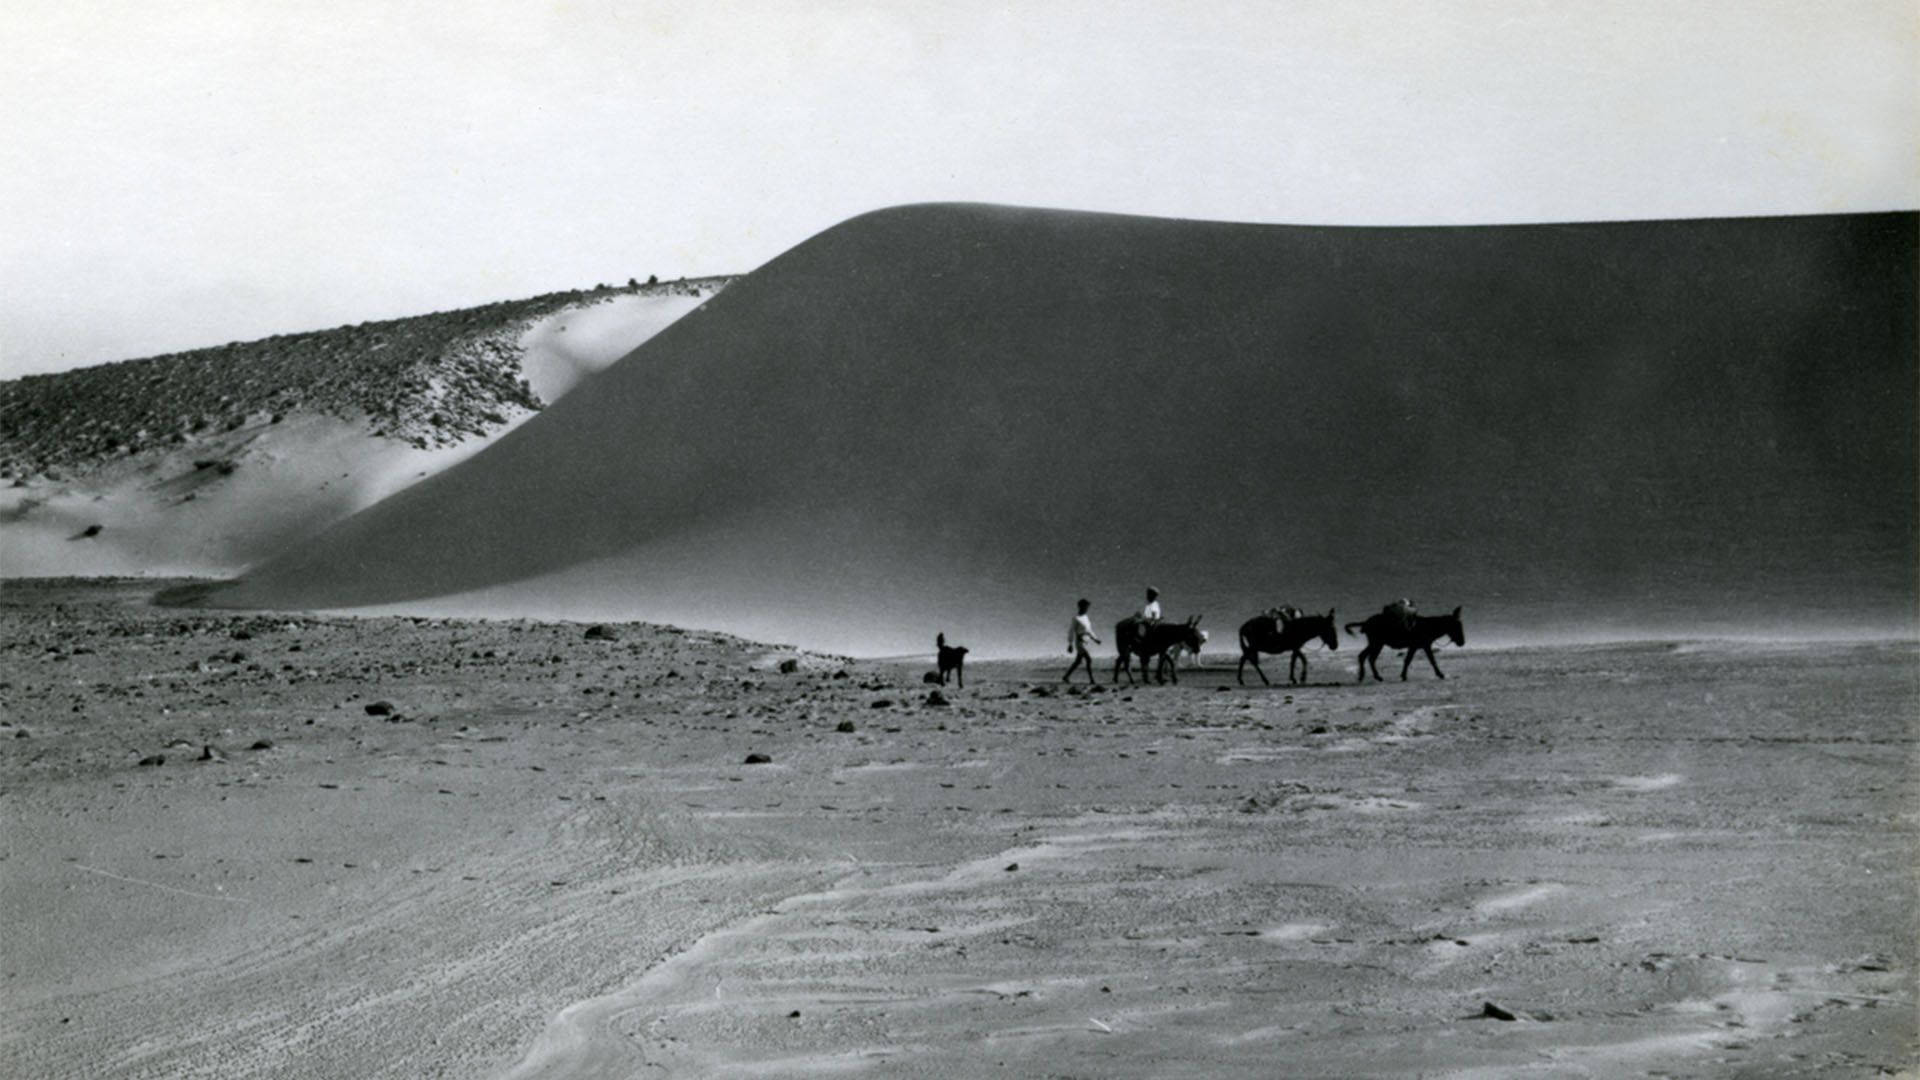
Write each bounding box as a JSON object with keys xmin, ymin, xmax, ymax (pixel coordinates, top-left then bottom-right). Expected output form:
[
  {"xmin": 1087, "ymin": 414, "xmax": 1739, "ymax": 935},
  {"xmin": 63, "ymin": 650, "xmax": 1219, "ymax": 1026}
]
[{"xmin": 221, "ymin": 206, "xmax": 1920, "ymax": 651}]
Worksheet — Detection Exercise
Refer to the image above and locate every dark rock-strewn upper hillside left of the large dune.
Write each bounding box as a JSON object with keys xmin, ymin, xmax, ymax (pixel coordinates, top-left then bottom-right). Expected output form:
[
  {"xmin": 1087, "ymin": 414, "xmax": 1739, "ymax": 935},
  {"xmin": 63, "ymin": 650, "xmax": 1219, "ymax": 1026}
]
[{"xmin": 0, "ymin": 277, "xmax": 732, "ymax": 480}]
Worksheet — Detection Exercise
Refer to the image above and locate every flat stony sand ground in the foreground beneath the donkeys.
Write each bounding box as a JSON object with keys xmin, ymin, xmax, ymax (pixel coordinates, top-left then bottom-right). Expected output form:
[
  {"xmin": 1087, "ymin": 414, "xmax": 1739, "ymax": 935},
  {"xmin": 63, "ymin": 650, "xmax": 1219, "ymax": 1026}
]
[{"xmin": 0, "ymin": 582, "xmax": 1920, "ymax": 1078}]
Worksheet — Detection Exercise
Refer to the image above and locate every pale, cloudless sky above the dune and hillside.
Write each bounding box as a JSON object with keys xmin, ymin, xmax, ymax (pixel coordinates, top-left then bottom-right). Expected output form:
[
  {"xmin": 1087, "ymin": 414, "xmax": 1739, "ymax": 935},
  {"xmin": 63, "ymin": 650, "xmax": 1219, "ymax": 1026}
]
[{"xmin": 0, "ymin": 0, "xmax": 1920, "ymax": 379}]
